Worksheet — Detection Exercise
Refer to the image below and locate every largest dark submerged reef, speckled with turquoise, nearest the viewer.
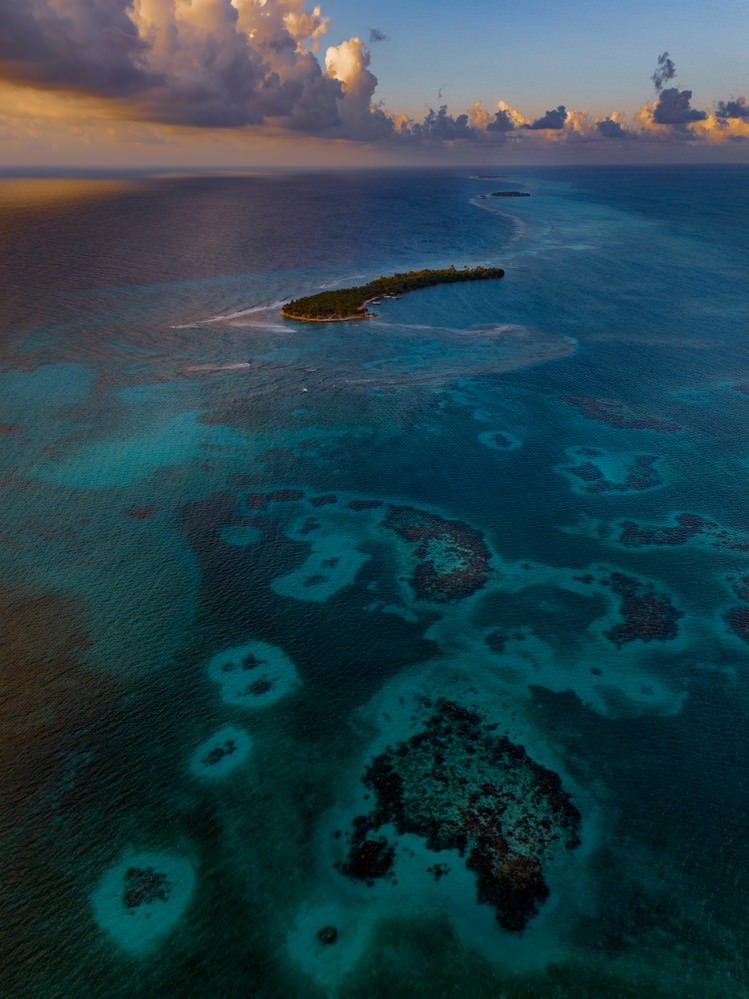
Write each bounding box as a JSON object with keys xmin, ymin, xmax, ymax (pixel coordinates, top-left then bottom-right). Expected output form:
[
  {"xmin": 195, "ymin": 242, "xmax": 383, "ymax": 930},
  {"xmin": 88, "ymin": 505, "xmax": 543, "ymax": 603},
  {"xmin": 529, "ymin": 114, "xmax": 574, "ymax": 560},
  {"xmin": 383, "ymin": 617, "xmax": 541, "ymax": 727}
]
[{"xmin": 338, "ymin": 698, "xmax": 580, "ymax": 931}]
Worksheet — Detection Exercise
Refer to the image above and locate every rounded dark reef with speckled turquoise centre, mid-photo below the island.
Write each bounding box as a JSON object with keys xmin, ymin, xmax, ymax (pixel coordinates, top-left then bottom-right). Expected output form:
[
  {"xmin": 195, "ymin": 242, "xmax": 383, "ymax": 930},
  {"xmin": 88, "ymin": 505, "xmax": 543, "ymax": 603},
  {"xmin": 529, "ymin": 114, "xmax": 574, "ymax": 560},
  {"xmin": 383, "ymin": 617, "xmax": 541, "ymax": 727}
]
[{"xmin": 382, "ymin": 506, "xmax": 491, "ymax": 603}]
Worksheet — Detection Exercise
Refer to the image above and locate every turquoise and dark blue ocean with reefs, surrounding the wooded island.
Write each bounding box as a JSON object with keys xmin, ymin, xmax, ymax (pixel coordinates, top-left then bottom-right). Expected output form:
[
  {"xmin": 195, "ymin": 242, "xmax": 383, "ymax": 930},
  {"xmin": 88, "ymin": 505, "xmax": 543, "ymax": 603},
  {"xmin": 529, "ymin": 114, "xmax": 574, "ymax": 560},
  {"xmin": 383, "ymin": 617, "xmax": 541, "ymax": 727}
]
[{"xmin": 0, "ymin": 166, "xmax": 749, "ymax": 999}]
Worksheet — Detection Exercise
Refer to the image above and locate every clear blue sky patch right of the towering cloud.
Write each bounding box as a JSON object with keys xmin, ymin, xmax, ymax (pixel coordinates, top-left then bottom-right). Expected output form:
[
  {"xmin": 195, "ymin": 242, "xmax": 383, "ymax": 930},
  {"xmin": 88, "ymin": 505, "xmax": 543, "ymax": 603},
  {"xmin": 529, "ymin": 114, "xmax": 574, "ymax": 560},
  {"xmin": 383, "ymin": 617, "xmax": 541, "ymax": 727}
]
[{"xmin": 330, "ymin": 0, "xmax": 749, "ymax": 115}]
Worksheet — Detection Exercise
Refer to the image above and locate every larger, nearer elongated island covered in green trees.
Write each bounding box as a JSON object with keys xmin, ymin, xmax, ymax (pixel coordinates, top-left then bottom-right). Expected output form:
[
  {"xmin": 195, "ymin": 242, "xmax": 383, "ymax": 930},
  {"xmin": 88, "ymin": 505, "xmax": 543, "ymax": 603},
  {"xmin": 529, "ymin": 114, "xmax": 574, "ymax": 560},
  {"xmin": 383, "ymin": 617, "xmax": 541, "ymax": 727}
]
[{"xmin": 281, "ymin": 266, "xmax": 505, "ymax": 323}]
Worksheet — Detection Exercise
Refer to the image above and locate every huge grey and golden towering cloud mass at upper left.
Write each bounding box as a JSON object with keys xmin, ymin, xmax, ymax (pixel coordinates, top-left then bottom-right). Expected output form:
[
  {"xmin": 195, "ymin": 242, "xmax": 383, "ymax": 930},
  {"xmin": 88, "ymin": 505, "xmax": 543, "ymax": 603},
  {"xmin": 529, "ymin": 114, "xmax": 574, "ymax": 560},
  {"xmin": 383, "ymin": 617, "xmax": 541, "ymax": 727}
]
[{"xmin": 0, "ymin": 0, "xmax": 382, "ymax": 132}]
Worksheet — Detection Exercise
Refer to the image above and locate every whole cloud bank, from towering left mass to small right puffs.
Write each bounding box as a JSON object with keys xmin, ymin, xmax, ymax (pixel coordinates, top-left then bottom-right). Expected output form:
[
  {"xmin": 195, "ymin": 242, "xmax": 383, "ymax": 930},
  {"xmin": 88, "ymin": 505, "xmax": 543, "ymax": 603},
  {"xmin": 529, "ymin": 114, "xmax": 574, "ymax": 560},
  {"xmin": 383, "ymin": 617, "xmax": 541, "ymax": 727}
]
[{"xmin": 0, "ymin": 15, "xmax": 749, "ymax": 158}]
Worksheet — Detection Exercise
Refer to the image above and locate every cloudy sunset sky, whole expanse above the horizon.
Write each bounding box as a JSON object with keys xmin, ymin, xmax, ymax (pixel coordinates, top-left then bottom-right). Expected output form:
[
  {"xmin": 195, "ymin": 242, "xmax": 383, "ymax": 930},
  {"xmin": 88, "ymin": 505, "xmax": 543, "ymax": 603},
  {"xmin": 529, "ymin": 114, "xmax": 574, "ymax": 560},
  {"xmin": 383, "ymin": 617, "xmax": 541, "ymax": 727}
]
[{"xmin": 0, "ymin": 0, "xmax": 749, "ymax": 168}]
